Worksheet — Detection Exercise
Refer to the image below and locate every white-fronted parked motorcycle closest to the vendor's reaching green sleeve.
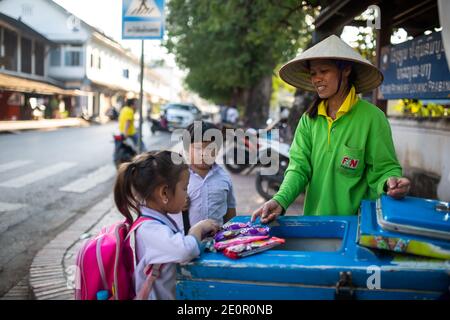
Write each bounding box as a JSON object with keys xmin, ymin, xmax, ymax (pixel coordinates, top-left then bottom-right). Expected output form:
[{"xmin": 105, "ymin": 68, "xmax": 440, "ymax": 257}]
[{"xmin": 255, "ymin": 142, "xmax": 290, "ymax": 200}]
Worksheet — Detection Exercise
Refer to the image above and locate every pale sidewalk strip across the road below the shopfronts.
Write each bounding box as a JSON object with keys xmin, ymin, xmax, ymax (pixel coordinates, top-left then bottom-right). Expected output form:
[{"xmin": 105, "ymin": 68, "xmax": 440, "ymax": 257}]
[{"xmin": 0, "ymin": 118, "xmax": 89, "ymax": 132}]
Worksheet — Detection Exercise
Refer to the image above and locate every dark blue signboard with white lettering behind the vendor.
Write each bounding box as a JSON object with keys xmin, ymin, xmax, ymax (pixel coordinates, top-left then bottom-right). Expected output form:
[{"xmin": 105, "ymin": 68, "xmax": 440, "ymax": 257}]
[{"xmin": 380, "ymin": 32, "xmax": 450, "ymax": 99}]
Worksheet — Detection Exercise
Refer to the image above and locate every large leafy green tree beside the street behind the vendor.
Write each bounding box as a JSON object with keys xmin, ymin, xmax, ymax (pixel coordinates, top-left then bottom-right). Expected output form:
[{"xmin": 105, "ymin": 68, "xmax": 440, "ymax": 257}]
[{"xmin": 165, "ymin": 0, "xmax": 317, "ymax": 127}]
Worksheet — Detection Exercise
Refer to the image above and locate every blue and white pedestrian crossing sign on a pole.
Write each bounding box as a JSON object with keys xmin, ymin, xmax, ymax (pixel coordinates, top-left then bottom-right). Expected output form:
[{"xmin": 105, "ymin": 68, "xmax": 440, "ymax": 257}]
[{"xmin": 122, "ymin": 0, "xmax": 164, "ymax": 40}]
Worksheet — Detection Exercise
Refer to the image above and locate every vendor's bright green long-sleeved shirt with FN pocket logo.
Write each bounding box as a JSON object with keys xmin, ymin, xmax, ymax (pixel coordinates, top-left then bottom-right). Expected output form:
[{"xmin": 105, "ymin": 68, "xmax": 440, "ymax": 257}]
[{"xmin": 274, "ymin": 99, "xmax": 402, "ymax": 215}]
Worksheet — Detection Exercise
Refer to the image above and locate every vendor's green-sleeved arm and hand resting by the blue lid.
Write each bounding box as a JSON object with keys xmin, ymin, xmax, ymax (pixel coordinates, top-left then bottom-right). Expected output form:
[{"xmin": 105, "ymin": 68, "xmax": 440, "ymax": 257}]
[{"xmin": 366, "ymin": 114, "xmax": 409, "ymax": 198}]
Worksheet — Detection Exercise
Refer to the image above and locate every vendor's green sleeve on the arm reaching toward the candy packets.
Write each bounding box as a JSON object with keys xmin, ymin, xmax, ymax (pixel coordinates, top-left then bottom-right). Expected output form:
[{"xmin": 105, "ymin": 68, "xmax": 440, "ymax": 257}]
[{"xmin": 273, "ymin": 114, "xmax": 312, "ymax": 210}]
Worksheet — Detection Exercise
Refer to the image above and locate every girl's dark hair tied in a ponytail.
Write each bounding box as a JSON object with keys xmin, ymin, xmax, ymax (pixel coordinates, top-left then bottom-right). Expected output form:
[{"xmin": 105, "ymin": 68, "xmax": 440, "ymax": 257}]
[{"xmin": 114, "ymin": 151, "xmax": 188, "ymax": 223}]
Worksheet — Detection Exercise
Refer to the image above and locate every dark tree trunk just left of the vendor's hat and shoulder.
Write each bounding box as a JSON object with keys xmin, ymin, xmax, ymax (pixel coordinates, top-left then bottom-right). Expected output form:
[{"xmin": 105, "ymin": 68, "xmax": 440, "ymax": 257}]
[{"xmin": 244, "ymin": 74, "xmax": 272, "ymax": 128}]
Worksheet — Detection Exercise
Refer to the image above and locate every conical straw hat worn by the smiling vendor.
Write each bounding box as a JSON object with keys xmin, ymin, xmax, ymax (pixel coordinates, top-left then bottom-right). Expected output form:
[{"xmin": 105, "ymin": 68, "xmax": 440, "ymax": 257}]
[{"xmin": 280, "ymin": 35, "xmax": 383, "ymax": 93}]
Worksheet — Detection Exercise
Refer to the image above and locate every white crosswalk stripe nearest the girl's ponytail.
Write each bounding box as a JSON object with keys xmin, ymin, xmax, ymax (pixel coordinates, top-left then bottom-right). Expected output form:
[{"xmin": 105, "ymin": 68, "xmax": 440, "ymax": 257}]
[{"xmin": 59, "ymin": 164, "xmax": 116, "ymax": 193}]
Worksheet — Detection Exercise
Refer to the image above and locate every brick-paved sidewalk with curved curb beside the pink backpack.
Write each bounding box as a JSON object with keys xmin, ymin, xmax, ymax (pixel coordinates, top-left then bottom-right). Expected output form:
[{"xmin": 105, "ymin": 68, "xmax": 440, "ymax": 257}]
[{"xmin": 2, "ymin": 166, "xmax": 303, "ymax": 300}]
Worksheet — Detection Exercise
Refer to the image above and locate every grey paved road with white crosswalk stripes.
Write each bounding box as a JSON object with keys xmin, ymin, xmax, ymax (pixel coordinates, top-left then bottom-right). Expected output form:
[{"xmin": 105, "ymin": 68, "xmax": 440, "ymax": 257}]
[{"xmin": 0, "ymin": 123, "xmax": 171, "ymax": 296}]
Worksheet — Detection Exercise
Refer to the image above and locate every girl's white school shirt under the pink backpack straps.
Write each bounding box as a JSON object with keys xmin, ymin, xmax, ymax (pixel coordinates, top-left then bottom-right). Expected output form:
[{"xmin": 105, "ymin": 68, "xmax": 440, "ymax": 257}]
[{"xmin": 134, "ymin": 207, "xmax": 200, "ymax": 300}]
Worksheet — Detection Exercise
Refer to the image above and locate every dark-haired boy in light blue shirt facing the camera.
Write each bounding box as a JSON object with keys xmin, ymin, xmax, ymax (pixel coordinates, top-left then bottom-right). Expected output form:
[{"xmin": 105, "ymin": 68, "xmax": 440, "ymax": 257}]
[{"xmin": 172, "ymin": 121, "xmax": 236, "ymax": 233}]
